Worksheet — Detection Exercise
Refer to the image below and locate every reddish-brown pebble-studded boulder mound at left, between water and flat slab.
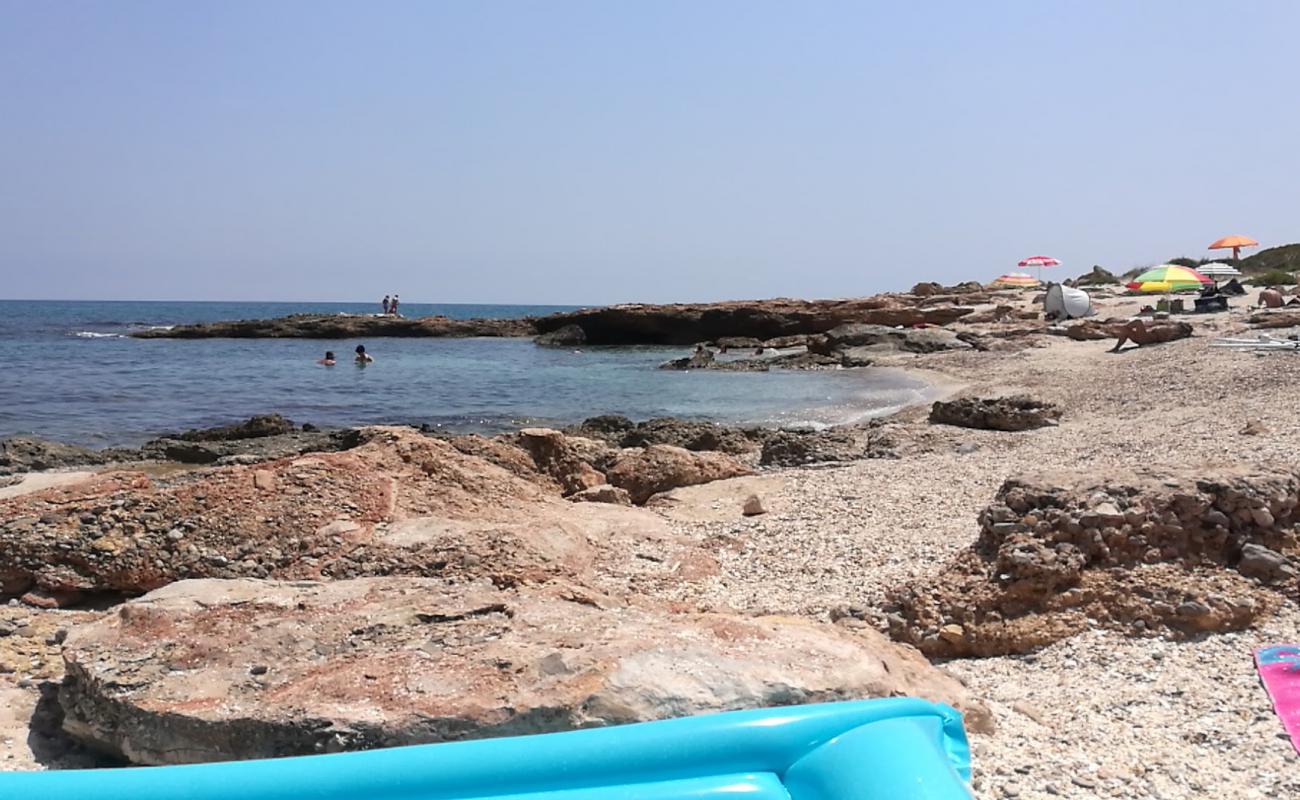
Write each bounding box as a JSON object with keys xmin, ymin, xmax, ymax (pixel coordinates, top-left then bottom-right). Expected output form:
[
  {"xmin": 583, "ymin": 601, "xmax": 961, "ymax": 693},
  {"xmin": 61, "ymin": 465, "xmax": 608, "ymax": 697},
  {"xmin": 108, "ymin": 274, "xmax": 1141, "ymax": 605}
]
[{"xmin": 0, "ymin": 428, "xmax": 691, "ymax": 593}]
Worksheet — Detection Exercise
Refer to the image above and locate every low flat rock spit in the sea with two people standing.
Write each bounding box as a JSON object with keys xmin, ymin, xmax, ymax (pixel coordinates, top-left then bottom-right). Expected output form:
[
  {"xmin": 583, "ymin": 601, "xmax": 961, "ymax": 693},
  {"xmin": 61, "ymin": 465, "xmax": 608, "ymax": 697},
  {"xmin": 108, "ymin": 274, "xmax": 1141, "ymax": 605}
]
[{"xmin": 131, "ymin": 313, "xmax": 534, "ymax": 340}]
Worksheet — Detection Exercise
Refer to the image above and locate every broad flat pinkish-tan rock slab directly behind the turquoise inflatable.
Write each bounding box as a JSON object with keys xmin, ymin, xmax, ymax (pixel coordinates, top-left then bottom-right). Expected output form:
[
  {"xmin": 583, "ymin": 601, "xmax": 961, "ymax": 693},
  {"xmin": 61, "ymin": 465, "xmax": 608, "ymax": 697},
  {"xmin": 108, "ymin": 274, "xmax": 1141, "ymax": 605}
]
[{"xmin": 60, "ymin": 578, "xmax": 988, "ymax": 764}]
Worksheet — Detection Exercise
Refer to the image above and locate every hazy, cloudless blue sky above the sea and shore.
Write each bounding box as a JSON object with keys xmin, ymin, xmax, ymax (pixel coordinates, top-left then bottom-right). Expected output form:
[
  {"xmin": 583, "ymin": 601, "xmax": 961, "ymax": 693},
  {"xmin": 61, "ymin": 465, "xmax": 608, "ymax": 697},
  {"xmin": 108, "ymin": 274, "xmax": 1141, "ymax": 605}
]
[{"xmin": 0, "ymin": 0, "xmax": 1300, "ymax": 303}]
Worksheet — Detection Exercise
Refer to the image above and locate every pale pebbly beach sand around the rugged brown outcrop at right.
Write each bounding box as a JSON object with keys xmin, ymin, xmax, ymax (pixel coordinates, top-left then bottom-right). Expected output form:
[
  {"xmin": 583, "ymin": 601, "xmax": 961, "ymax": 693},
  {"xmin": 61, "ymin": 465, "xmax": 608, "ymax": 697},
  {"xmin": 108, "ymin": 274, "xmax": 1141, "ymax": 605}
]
[{"xmin": 655, "ymin": 293, "xmax": 1300, "ymax": 799}]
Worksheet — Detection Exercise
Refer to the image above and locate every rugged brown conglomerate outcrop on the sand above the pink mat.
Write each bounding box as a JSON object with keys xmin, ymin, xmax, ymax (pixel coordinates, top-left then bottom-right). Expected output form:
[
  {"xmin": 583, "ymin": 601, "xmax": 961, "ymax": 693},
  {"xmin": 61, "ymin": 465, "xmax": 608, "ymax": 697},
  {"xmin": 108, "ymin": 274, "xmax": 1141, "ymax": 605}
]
[{"xmin": 887, "ymin": 467, "xmax": 1300, "ymax": 657}]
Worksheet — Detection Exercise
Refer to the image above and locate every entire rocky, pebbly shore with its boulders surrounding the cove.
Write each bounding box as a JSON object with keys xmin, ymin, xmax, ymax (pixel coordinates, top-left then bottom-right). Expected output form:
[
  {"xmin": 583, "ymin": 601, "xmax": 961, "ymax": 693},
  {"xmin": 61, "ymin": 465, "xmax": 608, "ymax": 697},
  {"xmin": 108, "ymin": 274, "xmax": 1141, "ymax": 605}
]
[{"xmin": 0, "ymin": 278, "xmax": 1300, "ymax": 797}]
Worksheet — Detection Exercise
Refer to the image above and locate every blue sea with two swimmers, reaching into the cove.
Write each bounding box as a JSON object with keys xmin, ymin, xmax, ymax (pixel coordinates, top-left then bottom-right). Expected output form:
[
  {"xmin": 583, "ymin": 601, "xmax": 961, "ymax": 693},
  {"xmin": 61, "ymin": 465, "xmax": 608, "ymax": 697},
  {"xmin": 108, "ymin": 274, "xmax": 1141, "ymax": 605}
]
[{"xmin": 0, "ymin": 300, "xmax": 931, "ymax": 446}]
